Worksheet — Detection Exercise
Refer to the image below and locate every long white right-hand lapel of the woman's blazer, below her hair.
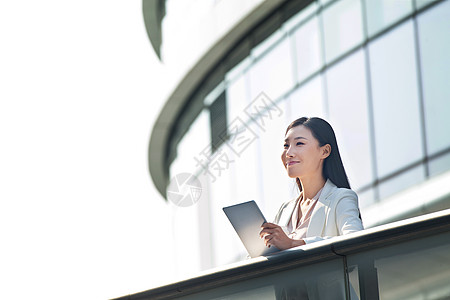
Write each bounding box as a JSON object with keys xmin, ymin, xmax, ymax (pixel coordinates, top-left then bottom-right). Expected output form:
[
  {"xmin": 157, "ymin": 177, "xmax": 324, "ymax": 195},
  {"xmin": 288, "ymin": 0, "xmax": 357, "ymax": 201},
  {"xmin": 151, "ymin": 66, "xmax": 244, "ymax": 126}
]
[{"xmin": 306, "ymin": 179, "xmax": 336, "ymax": 237}]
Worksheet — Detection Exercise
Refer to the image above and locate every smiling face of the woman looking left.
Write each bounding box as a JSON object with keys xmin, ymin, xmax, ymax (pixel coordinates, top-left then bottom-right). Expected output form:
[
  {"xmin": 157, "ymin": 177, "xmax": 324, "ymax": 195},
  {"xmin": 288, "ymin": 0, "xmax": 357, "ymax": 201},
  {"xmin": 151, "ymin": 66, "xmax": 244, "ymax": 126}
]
[{"xmin": 281, "ymin": 125, "xmax": 331, "ymax": 180}]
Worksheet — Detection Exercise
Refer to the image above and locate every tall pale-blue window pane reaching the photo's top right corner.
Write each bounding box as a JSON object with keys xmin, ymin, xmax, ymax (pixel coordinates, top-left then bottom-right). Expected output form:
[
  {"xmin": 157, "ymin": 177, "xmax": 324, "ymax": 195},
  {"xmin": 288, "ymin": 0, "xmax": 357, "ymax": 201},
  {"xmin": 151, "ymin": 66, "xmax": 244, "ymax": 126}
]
[{"xmin": 418, "ymin": 1, "xmax": 450, "ymax": 154}]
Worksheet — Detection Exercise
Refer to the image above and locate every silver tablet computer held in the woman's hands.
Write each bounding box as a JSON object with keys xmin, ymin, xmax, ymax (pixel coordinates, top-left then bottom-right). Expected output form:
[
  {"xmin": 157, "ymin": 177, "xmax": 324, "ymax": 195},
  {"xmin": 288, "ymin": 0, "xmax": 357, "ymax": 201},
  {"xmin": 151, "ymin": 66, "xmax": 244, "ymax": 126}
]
[{"xmin": 223, "ymin": 200, "xmax": 280, "ymax": 257}]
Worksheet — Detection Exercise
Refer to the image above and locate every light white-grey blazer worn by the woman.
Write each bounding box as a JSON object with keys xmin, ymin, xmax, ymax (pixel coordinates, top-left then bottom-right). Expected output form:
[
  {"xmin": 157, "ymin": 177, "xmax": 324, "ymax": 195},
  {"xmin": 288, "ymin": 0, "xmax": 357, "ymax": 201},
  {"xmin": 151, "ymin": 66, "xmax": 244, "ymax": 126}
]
[{"xmin": 274, "ymin": 179, "xmax": 364, "ymax": 244}]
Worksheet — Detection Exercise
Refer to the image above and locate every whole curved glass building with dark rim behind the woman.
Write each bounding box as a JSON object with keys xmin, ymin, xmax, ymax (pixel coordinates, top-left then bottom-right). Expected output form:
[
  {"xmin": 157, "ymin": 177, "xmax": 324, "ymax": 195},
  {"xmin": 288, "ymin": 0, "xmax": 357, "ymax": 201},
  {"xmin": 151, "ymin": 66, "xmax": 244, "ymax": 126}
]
[{"xmin": 143, "ymin": 0, "xmax": 450, "ymax": 271}]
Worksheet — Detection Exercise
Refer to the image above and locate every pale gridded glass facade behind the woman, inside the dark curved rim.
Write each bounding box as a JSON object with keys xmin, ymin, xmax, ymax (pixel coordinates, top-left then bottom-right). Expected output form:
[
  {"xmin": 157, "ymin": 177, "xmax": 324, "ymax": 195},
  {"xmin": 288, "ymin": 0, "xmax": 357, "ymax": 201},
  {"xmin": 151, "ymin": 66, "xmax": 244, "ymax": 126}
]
[{"xmin": 170, "ymin": 0, "xmax": 450, "ymax": 265}]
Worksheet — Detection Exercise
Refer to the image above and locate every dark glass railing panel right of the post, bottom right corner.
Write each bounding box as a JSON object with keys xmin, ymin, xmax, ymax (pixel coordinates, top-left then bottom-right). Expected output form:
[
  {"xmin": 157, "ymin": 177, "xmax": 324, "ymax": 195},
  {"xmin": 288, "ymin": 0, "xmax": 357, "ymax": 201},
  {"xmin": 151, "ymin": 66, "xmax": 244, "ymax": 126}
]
[{"xmin": 347, "ymin": 232, "xmax": 450, "ymax": 300}]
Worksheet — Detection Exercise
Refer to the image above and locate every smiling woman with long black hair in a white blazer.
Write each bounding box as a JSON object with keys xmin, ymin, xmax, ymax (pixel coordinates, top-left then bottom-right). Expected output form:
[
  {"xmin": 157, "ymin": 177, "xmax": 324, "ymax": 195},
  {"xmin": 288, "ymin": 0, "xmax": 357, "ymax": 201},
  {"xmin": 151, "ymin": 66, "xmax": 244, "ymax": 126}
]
[{"xmin": 260, "ymin": 117, "xmax": 363, "ymax": 250}]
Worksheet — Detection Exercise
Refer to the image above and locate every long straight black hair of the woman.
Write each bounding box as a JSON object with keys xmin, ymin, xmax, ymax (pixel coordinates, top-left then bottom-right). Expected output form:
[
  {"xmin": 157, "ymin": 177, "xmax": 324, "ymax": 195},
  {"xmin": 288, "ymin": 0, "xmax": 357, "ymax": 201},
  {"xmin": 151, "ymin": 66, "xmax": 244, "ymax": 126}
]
[{"xmin": 286, "ymin": 117, "xmax": 350, "ymax": 191}]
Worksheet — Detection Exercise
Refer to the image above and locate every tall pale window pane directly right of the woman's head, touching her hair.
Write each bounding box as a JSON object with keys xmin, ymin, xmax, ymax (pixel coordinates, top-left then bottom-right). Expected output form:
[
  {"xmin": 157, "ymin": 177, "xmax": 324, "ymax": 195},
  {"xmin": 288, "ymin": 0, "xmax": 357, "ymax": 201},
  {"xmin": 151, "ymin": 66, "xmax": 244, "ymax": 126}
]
[{"xmin": 327, "ymin": 51, "xmax": 374, "ymax": 189}]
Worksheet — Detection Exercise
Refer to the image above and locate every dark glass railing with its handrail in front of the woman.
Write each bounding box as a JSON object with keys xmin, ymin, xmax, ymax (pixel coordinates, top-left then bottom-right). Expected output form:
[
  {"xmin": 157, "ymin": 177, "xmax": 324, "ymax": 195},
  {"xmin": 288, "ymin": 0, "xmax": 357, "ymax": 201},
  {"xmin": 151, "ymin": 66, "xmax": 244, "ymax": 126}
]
[{"xmin": 113, "ymin": 210, "xmax": 450, "ymax": 300}]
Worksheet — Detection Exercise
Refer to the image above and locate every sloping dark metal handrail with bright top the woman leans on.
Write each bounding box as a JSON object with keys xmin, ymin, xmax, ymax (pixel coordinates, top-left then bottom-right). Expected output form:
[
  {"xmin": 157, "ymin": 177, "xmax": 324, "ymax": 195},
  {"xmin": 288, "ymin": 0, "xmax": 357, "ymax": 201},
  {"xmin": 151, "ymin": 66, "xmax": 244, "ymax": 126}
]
[{"xmin": 116, "ymin": 209, "xmax": 450, "ymax": 300}]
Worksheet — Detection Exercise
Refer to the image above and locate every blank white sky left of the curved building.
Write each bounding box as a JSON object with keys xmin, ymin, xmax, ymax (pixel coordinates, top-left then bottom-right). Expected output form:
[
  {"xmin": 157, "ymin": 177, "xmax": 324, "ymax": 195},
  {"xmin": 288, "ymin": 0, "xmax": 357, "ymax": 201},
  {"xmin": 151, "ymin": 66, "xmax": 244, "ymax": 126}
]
[{"xmin": 0, "ymin": 0, "xmax": 173, "ymax": 299}]
